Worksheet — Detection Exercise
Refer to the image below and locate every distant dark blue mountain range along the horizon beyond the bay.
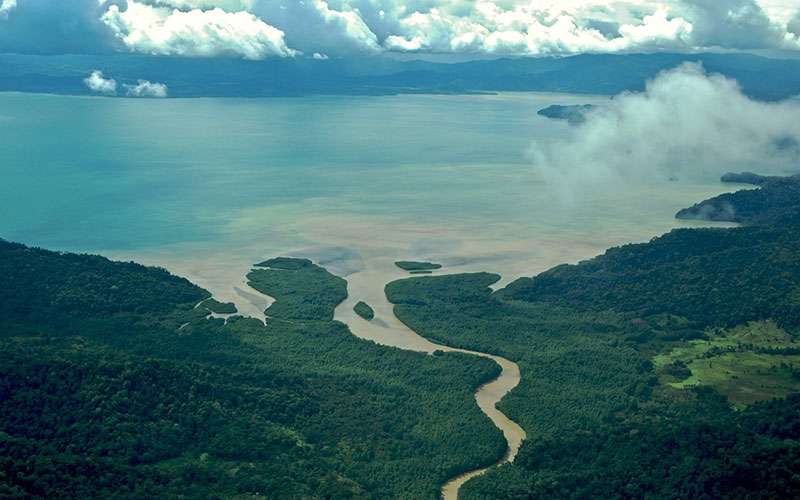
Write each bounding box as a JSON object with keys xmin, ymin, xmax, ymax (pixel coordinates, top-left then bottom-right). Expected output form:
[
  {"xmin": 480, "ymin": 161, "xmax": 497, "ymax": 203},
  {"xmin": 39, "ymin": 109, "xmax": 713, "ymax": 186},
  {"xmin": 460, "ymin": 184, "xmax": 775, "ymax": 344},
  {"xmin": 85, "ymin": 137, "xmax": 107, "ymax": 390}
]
[{"xmin": 0, "ymin": 53, "xmax": 800, "ymax": 100}]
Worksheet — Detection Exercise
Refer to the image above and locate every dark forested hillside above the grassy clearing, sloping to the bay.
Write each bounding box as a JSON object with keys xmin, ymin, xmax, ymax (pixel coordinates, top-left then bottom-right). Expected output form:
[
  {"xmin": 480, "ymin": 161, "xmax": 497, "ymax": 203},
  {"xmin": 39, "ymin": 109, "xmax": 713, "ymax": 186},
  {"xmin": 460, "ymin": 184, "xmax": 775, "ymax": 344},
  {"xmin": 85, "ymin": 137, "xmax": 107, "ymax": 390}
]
[{"xmin": 502, "ymin": 225, "xmax": 800, "ymax": 326}]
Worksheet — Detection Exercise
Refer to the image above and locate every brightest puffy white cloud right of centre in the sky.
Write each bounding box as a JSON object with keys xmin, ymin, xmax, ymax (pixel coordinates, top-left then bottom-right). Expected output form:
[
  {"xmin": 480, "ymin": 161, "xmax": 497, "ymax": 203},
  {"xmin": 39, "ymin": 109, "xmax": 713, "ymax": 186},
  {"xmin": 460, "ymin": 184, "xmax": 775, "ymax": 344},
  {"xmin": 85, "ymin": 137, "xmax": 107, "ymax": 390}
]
[{"xmin": 384, "ymin": 0, "xmax": 692, "ymax": 55}]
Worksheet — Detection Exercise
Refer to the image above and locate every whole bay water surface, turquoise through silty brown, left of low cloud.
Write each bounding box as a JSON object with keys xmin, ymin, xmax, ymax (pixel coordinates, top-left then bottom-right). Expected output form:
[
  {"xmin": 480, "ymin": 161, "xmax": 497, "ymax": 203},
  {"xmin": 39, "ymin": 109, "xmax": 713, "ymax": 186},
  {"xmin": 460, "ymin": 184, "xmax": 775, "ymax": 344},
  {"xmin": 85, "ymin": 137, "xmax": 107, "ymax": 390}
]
[{"xmin": 0, "ymin": 93, "xmax": 726, "ymax": 312}]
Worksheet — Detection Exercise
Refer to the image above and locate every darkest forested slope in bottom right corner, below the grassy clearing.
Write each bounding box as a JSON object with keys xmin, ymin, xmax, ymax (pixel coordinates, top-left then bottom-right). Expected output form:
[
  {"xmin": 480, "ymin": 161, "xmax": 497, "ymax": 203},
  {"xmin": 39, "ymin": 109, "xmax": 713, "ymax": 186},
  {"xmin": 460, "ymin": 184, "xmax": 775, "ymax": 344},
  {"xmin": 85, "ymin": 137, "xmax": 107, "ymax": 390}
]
[{"xmin": 463, "ymin": 391, "xmax": 800, "ymax": 499}]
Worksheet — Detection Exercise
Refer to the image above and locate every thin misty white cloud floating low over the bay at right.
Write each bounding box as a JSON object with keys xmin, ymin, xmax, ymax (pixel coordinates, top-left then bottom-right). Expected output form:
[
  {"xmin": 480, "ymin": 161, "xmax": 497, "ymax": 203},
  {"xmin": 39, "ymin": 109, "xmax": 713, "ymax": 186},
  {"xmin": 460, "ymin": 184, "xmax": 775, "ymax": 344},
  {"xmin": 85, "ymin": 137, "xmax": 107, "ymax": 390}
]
[{"xmin": 530, "ymin": 64, "xmax": 800, "ymax": 193}]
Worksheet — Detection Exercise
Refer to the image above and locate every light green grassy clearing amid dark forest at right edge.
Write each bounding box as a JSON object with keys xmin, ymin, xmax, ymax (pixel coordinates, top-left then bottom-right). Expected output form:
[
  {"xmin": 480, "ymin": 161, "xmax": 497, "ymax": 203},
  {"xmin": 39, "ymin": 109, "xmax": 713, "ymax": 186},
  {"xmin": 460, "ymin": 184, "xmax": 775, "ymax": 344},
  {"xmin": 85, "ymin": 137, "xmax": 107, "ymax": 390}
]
[{"xmin": 653, "ymin": 321, "xmax": 800, "ymax": 408}]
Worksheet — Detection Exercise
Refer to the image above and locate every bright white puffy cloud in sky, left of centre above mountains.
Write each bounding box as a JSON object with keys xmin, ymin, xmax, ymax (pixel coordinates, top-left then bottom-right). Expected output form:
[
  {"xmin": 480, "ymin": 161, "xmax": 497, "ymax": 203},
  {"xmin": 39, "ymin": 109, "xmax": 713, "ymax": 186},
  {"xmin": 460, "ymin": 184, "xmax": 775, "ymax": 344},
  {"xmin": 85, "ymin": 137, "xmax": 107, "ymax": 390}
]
[{"xmin": 102, "ymin": 0, "xmax": 297, "ymax": 59}]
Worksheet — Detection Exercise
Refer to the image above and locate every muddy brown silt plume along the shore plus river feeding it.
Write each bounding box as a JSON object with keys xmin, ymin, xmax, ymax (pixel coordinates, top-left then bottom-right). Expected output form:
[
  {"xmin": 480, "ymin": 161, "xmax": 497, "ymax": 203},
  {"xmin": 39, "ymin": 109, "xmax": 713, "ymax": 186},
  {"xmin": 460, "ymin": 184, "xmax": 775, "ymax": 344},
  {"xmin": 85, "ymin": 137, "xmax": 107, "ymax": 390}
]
[{"xmin": 103, "ymin": 183, "xmax": 730, "ymax": 498}]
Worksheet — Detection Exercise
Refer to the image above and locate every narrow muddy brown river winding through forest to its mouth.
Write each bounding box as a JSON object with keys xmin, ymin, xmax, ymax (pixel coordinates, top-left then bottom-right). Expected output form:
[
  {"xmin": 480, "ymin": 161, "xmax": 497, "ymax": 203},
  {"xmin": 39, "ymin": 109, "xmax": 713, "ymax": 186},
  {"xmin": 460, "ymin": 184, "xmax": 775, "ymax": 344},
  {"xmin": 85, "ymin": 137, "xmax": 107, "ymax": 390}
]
[{"xmin": 332, "ymin": 259, "xmax": 526, "ymax": 500}]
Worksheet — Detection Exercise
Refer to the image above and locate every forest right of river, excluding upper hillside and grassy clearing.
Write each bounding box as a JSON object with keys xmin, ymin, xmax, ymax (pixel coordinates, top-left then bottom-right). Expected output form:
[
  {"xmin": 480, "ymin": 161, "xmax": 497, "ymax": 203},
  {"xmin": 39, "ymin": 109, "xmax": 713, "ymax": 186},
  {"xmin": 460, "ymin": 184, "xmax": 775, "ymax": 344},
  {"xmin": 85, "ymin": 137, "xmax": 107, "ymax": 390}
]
[{"xmin": 387, "ymin": 275, "xmax": 800, "ymax": 498}]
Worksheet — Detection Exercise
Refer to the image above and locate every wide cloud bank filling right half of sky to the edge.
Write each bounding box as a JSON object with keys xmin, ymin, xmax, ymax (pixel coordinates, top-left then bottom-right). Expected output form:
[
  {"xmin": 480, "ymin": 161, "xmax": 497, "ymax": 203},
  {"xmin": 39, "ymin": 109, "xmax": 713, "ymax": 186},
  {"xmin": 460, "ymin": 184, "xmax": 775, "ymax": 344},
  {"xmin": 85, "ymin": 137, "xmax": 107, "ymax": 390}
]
[{"xmin": 374, "ymin": 0, "xmax": 800, "ymax": 55}]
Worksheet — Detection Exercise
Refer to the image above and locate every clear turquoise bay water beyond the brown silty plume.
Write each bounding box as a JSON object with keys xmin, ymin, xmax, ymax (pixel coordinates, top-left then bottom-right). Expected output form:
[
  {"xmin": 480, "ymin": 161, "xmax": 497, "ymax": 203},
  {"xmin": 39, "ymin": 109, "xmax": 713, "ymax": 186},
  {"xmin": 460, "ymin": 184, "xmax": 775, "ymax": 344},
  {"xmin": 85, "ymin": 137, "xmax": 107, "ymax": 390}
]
[{"xmin": 0, "ymin": 94, "xmax": 568, "ymax": 250}]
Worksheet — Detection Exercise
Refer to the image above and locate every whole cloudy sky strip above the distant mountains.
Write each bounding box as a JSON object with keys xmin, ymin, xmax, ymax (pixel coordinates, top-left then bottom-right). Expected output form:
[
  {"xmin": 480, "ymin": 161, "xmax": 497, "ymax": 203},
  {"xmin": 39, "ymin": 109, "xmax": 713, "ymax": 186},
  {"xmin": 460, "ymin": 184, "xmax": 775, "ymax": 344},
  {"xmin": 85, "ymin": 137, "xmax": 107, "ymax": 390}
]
[{"xmin": 0, "ymin": 0, "xmax": 800, "ymax": 60}]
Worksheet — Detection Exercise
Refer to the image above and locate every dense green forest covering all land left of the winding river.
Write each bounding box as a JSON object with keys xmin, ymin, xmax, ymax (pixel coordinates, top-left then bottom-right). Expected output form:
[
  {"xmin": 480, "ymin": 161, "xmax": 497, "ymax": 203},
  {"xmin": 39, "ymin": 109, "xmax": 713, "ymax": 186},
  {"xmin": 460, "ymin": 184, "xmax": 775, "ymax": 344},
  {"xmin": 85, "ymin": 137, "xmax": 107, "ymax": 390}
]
[{"xmin": 0, "ymin": 241, "xmax": 505, "ymax": 498}]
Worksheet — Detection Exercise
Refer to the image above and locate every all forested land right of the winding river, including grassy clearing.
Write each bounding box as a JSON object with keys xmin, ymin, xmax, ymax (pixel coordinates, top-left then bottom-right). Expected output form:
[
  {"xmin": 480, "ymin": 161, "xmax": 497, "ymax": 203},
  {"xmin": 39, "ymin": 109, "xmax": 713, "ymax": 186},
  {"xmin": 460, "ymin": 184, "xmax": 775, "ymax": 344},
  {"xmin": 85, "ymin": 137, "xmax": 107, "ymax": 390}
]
[{"xmin": 387, "ymin": 174, "xmax": 800, "ymax": 499}]
